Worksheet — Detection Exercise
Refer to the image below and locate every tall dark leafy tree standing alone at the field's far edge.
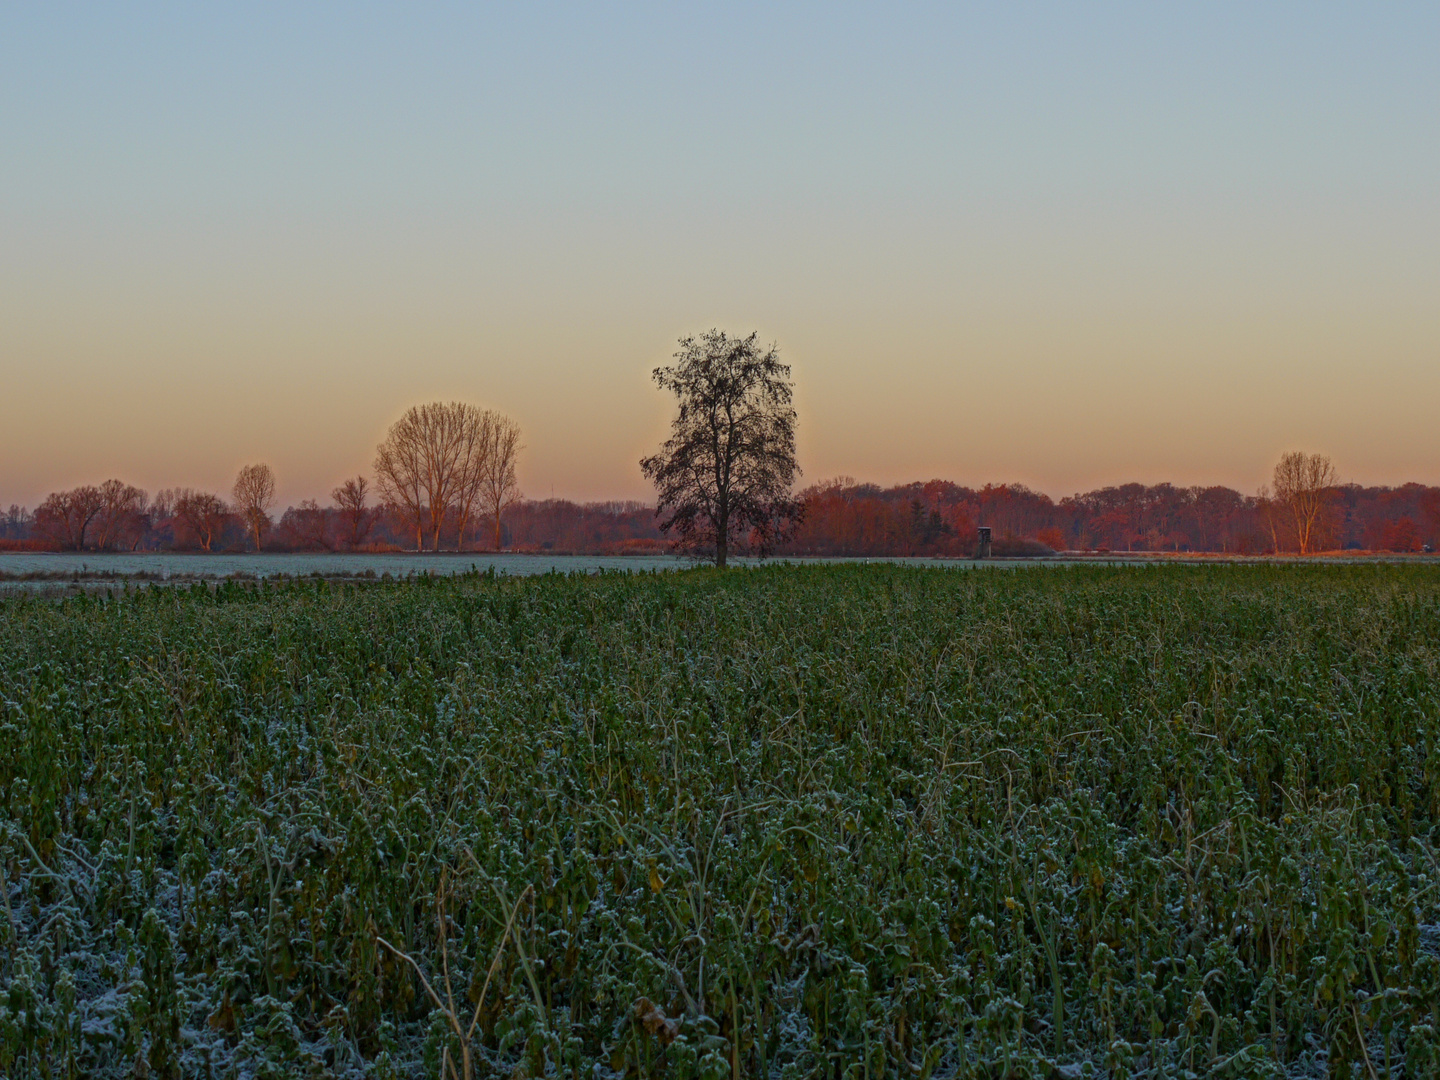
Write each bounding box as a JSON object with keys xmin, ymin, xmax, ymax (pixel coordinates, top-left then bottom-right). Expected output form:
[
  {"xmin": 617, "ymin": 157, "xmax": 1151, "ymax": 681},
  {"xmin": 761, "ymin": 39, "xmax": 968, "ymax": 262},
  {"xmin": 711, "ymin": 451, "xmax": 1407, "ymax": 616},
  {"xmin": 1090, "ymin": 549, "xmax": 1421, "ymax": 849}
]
[{"xmin": 639, "ymin": 330, "xmax": 802, "ymax": 567}]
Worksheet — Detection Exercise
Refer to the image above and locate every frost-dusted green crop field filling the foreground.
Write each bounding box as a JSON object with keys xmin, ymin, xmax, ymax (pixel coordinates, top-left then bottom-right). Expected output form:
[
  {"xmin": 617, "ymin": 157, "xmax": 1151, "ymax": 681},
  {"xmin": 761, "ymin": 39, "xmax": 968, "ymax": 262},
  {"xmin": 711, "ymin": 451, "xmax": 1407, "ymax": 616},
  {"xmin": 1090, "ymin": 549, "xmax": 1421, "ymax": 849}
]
[{"xmin": 0, "ymin": 564, "xmax": 1440, "ymax": 1079}]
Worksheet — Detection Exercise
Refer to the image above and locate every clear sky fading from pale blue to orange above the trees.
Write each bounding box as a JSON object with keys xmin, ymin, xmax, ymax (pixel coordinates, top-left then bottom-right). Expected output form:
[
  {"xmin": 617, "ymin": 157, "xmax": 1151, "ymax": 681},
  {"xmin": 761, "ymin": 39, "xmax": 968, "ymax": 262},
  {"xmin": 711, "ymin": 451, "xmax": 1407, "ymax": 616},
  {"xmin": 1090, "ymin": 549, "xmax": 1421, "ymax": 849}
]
[{"xmin": 0, "ymin": 3, "xmax": 1440, "ymax": 505}]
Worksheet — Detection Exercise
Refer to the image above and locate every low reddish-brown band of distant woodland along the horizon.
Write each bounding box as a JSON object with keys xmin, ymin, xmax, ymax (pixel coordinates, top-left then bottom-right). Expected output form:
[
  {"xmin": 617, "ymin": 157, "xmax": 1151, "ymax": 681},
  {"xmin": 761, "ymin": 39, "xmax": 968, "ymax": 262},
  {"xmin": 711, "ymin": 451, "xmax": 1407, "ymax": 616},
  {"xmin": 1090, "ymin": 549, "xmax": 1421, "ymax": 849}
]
[{"xmin": 0, "ymin": 477, "xmax": 1440, "ymax": 557}]
